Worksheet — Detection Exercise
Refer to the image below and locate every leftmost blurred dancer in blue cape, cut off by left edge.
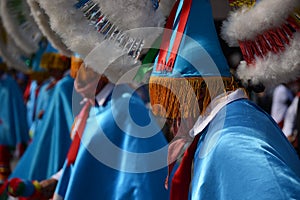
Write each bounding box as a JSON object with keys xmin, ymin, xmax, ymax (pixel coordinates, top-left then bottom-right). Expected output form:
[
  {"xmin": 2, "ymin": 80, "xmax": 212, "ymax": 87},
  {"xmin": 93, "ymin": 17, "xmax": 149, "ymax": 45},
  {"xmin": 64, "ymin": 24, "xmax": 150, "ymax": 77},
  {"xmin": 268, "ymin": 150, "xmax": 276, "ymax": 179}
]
[{"xmin": 0, "ymin": 62, "xmax": 29, "ymax": 182}]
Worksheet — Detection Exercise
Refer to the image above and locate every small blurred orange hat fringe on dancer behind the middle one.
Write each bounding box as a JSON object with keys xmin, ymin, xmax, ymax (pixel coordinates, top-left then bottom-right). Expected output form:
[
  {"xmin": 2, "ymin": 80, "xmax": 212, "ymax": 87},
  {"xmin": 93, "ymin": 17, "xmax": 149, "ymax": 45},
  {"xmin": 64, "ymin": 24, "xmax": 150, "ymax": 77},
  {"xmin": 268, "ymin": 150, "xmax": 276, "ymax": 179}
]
[{"xmin": 40, "ymin": 53, "xmax": 71, "ymax": 71}]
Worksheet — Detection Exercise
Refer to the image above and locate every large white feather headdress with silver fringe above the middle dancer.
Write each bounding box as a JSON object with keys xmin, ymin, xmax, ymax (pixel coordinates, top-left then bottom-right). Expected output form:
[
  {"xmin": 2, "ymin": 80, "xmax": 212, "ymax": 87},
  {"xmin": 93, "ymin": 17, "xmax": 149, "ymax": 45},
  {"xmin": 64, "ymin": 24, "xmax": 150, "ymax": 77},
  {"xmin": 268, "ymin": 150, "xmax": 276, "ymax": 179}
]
[{"xmin": 36, "ymin": 0, "xmax": 174, "ymax": 82}]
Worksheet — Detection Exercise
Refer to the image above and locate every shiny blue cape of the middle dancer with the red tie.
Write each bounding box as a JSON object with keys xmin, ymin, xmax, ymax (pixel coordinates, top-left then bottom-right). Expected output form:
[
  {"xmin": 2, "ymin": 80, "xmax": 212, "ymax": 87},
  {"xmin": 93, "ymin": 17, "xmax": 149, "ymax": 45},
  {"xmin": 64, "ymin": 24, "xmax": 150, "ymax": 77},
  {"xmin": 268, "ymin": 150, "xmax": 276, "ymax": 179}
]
[{"xmin": 56, "ymin": 85, "xmax": 169, "ymax": 200}]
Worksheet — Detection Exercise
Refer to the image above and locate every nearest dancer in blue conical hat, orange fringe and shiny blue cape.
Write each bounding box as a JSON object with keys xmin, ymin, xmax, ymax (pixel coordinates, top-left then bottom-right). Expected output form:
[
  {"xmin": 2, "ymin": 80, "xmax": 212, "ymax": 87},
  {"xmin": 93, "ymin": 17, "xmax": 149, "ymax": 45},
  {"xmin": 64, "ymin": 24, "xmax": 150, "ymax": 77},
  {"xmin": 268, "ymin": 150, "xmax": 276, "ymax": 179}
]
[{"xmin": 150, "ymin": 0, "xmax": 300, "ymax": 200}]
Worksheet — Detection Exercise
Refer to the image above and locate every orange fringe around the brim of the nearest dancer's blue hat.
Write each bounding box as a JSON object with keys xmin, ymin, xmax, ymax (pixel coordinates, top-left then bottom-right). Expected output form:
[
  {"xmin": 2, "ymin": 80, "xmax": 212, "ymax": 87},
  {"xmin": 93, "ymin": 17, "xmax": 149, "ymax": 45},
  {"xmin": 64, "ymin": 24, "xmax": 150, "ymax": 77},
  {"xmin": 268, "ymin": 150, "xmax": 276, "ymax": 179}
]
[{"xmin": 149, "ymin": 77, "xmax": 238, "ymax": 119}]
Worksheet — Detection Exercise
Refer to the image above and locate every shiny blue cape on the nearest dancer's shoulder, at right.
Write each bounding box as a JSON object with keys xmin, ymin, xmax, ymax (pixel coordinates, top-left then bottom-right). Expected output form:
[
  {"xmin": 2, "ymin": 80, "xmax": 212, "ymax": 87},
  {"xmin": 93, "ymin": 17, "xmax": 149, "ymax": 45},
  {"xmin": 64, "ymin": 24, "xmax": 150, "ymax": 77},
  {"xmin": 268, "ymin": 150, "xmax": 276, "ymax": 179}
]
[{"xmin": 191, "ymin": 100, "xmax": 300, "ymax": 200}]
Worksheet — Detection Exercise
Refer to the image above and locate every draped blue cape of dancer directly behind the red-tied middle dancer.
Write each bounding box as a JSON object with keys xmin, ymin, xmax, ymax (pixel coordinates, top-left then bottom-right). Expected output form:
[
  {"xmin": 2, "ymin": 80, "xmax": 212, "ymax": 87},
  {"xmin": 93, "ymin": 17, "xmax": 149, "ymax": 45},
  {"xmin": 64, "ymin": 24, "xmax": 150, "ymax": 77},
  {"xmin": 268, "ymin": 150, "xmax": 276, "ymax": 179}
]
[{"xmin": 9, "ymin": 75, "xmax": 74, "ymax": 180}]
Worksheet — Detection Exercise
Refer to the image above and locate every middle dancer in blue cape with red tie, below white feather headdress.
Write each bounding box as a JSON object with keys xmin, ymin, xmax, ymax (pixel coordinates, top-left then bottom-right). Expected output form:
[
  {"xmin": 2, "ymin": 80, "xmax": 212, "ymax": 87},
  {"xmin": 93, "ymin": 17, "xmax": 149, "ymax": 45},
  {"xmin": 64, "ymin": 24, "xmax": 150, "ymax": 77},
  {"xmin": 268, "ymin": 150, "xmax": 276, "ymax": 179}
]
[{"xmin": 11, "ymin": 64, "xmax": 168, "ymax": 199}]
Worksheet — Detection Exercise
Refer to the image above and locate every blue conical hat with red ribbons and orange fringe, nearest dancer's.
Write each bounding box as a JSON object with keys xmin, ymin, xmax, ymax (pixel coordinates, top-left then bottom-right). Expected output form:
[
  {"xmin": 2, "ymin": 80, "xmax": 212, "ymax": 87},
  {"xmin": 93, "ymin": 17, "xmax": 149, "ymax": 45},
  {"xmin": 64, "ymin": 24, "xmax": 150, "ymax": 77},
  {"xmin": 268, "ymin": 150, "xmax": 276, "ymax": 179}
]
[{"xmin": 149, "ymin": 0, "xmax": 237, "ymax": 123}]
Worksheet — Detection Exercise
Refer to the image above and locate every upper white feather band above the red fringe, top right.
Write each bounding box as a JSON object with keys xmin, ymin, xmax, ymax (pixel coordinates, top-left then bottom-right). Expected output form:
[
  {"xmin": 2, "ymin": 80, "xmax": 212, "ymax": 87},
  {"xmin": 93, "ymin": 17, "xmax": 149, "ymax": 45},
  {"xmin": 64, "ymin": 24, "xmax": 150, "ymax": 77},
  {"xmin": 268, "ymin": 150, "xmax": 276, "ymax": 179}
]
[{"xmin": 222, "ymin": 0, "xmax": 300, "ymax": 46}]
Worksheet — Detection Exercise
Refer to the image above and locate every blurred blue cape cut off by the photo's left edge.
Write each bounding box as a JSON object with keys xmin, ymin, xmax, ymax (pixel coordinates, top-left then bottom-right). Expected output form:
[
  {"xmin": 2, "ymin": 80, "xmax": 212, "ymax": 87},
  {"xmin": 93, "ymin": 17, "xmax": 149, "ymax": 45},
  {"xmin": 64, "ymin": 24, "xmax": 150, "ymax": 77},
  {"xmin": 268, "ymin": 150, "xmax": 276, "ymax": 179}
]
[{"xmin": 0, "ymin": 75, "xmax": 29, "ymax": 148}]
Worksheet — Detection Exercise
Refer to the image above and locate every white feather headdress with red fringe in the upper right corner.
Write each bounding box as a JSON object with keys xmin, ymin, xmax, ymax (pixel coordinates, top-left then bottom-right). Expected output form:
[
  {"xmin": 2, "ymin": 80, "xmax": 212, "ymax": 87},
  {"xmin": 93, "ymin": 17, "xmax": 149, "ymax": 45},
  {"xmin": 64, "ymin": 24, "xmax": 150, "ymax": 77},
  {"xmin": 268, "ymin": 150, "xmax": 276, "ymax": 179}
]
[{"xmin": 222, "ymin": 0, "xmax": 300, "ymax": 87}]
